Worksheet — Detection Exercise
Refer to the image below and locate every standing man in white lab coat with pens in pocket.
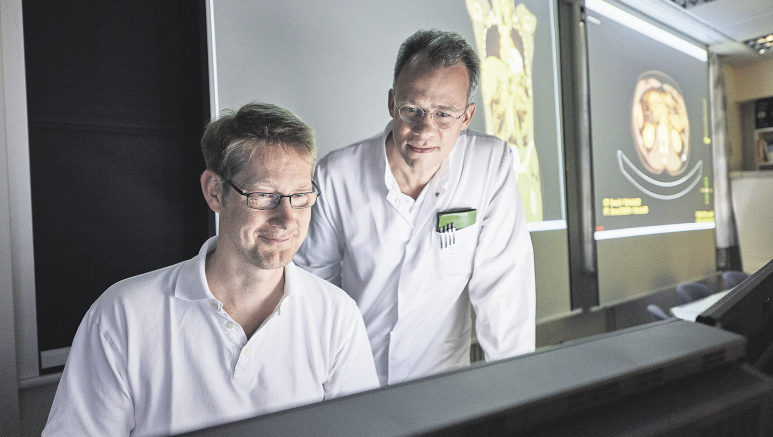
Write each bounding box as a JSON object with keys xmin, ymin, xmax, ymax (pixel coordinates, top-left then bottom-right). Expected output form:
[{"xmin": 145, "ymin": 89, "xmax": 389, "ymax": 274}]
[{"xmin": 295, "ymin": 30, "xmax": 535, "ymax": 385}]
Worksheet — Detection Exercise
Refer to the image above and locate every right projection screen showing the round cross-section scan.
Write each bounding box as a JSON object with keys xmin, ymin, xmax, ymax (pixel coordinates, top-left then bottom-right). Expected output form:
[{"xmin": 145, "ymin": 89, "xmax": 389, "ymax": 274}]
[{"xmin": 587, "ymin": 2, "xmax": 715, "ymax": 240}]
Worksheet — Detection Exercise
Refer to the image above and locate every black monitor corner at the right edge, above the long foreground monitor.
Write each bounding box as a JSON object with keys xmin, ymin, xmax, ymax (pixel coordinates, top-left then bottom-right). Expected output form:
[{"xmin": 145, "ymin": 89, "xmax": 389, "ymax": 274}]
[{"xmin": 696, "ymin": 260, "xmax": 773, "ymax": 375}]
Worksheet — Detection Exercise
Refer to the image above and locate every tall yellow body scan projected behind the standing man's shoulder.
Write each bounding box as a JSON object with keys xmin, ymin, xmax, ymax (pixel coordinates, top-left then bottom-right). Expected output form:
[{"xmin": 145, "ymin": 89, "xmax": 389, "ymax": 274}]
[{"xmin": 467, "ymin": 0, "xmax": 543, "ymax": 222}]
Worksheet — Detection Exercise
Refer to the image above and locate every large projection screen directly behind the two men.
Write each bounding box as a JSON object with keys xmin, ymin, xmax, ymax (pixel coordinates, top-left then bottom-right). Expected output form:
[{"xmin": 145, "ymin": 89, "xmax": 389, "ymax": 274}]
[{"xmin": 207, "ymin": 0, "xmax": 566, "ymax": 231}]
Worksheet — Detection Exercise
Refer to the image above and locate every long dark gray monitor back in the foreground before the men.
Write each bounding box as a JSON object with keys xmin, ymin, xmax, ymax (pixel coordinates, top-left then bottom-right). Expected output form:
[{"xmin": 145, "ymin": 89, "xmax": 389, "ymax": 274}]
[{"xmin": 186, "ymin": 319, "xmax": 773, "ymax": 437}]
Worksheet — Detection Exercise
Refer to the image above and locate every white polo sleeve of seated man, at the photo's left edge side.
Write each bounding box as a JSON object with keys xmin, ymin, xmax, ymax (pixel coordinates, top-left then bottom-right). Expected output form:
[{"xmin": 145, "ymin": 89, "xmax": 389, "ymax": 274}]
[{"xmin": 42, "ymin": 310, "xmax": 135, "ymax": 436}]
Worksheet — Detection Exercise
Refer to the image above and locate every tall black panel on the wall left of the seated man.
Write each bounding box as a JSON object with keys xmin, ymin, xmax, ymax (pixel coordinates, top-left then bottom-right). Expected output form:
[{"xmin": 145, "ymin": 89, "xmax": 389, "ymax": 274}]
[{"xmin": 22, "ymin": 0, "xmax": 212, "ymax": 362}]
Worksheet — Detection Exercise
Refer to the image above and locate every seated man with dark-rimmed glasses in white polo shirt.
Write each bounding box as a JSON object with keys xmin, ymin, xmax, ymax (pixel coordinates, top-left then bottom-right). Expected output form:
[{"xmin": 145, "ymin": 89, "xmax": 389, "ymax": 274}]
[{"xmin": 43, "ymin": 104, "xmax": 378, "ymax": 436}]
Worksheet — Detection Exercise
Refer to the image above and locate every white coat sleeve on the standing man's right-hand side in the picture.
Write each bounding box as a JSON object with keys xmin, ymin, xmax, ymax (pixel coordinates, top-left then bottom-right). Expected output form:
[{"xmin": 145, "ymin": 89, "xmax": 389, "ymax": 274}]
[{"xmin": 468, "ymin": 144, "xmax": 536, "ymax": 361}]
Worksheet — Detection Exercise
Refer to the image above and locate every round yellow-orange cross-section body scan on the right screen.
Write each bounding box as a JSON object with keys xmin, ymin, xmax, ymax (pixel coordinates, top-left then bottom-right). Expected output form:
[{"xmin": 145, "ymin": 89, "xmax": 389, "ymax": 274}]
[{"xmin": 631, "ymin": 71, "xmax": 690, "ymax": 176}]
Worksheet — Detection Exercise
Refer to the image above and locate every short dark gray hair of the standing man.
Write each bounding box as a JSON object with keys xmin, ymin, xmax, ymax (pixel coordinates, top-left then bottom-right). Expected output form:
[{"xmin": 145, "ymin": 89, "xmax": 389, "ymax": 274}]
[{"xmin": 392, "ymin": 29, "xmax": 480, "ymax": 105}]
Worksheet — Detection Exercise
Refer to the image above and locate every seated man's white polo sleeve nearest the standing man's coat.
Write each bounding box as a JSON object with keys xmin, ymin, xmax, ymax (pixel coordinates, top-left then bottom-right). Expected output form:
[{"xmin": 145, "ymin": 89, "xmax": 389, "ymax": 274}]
[{"xmin": 324, "ymin": 300, "xmax": 379, "ymax": 399}]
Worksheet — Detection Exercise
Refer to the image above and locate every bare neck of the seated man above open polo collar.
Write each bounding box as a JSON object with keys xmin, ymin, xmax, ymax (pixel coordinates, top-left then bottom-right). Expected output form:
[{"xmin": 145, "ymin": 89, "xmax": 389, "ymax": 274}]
[{"xmin": 204, "ymin": 247, "xmax": 284, "ymax": 338}]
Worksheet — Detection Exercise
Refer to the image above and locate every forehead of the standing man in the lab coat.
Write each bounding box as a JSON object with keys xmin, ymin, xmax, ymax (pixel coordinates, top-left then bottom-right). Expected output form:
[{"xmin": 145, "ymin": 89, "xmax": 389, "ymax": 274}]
[{"xmin": 395, "ymin": 55, "xmax": 469, "ymax": 106}]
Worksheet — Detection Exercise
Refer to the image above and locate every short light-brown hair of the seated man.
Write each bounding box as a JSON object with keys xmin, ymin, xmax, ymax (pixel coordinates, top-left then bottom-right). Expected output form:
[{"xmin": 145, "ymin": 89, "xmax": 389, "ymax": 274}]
[{"xmin": 201, "ymin": 103, "xmax": 317, "ymax": 179}]
